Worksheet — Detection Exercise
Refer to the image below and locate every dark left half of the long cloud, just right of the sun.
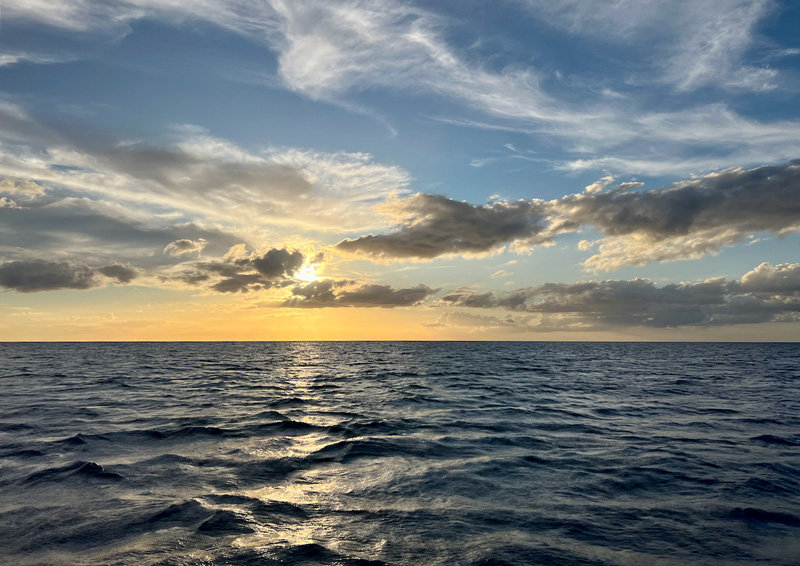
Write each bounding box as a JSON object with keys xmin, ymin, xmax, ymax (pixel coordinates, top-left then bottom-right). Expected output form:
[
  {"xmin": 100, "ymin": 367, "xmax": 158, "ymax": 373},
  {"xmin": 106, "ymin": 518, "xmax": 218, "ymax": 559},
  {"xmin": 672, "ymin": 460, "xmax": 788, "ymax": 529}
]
[{"xmin": 336, "ymin": 193, "xmax": 547, "ymax": 259}]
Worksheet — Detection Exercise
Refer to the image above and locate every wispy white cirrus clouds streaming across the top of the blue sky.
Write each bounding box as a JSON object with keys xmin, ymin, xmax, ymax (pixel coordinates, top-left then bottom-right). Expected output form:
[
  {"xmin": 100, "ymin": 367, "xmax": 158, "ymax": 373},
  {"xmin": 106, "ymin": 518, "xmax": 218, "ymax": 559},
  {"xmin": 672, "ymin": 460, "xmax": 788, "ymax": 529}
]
[{"xmin": 4, "ymin": 0, "xmax": 800, "ymax": 174}]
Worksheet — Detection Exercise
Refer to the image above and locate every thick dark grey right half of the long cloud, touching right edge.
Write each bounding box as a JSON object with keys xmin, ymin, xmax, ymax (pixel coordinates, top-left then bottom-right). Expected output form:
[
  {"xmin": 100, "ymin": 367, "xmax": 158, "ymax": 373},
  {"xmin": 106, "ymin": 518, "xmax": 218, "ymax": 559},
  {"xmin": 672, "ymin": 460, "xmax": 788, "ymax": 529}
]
[{"xmin": 551, "ymin": 161, "xmax": 800, "ymax": 271}]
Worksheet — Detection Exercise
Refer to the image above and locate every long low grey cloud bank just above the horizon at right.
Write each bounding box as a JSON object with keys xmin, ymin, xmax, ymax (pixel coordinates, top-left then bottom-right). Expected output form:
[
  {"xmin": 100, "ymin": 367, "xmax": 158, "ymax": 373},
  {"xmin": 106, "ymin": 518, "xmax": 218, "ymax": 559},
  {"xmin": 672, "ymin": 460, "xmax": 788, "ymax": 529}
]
[{"xmin": 439, "ymin": 263, "xmax": 800, "ymax": 328}]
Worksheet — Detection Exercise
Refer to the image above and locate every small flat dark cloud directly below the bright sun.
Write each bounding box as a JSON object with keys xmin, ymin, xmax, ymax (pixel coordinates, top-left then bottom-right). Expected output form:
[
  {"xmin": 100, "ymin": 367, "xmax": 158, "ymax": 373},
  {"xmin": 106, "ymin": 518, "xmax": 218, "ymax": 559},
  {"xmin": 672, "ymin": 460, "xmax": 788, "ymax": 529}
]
[{"xmin": 284, "ymin": 279, "xmax": 437, "ymax": 308}]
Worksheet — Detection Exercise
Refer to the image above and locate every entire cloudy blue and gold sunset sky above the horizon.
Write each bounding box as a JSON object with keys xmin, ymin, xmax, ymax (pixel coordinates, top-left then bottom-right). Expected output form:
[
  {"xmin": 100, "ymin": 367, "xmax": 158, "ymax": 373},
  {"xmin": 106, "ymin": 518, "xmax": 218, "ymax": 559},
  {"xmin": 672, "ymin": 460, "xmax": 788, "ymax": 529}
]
[{"xmin": 0, "ymin": 0, "xmax": 800, "ymax": 341}]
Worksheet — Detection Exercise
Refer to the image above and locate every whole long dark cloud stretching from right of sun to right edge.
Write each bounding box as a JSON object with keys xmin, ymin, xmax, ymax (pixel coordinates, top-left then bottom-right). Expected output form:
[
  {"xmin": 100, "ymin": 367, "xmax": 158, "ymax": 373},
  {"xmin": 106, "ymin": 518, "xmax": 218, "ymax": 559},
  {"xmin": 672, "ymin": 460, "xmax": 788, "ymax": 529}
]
[{"xmin": 336, "ymin": 160, "xmax": 800, "ymax": 270}]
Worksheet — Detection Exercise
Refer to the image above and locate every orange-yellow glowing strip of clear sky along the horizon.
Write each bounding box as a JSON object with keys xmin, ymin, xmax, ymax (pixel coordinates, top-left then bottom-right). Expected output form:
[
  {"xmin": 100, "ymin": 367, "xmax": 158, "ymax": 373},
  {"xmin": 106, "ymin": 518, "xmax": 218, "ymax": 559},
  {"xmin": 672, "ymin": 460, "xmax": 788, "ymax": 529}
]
[{"xmin": 0, "ymin": 296, "xmax": 796, "ymax": 341}]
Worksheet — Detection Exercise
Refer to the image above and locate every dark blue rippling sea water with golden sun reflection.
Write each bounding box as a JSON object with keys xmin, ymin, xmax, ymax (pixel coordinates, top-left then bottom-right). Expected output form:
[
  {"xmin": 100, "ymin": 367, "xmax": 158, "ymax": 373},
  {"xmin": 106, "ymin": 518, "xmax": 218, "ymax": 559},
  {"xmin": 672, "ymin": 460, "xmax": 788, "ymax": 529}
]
[{"xmin": 0, "ymin": 342, "xmax": 800, "ymax": 566}]
